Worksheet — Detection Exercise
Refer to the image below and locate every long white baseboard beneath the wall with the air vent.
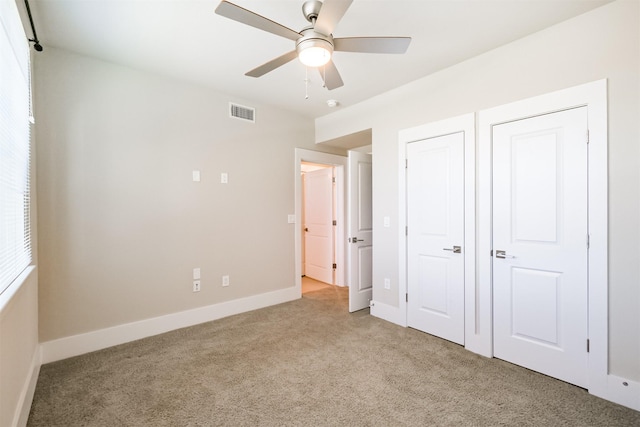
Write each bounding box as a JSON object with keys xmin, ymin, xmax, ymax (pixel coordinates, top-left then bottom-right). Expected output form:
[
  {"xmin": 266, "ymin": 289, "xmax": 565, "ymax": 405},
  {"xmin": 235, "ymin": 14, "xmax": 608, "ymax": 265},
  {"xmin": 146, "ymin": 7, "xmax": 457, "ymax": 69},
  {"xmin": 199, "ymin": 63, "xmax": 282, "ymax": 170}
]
[{"xmin": 40, "ymin": 287, "xmax": 300, "ymax": 364}]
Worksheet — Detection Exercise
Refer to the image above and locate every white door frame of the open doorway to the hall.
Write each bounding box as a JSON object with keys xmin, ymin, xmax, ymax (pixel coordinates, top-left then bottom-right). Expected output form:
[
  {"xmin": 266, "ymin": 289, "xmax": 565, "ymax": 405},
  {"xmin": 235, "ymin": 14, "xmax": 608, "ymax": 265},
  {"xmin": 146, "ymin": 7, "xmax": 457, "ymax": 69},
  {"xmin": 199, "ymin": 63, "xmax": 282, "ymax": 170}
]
[{"xmin": 294, "ymin": 148, "xmax": 348, "ymax": 295}]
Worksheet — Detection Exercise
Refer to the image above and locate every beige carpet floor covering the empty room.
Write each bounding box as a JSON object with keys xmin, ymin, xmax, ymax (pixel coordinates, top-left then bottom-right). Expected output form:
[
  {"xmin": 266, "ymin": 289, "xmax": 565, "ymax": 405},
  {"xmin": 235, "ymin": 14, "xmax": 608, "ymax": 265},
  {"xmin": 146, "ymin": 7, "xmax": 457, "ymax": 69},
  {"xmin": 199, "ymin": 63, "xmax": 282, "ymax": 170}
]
[{"xmin": 28, "ymin": 287, "xmax": 640, "ymax": 427}]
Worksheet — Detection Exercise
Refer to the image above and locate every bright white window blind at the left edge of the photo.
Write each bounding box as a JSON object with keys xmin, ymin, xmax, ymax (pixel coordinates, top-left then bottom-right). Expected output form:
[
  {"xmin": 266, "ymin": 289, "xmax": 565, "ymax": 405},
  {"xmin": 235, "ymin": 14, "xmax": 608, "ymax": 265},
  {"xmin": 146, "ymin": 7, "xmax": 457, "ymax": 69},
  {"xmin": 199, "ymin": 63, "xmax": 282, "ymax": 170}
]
[{"xmin": 0, "ymin": 1, "xmax": 31, "ymax": 293}]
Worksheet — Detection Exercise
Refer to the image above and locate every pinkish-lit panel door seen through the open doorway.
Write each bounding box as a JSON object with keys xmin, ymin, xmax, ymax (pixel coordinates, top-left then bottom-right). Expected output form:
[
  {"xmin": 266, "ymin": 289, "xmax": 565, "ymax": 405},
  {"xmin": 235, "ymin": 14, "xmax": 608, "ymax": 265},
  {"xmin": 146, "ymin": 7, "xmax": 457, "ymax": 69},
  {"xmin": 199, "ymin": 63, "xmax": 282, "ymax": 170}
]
[{"xmin": 303, "ymin": 168, "xmax": 334, "ymax": 284}]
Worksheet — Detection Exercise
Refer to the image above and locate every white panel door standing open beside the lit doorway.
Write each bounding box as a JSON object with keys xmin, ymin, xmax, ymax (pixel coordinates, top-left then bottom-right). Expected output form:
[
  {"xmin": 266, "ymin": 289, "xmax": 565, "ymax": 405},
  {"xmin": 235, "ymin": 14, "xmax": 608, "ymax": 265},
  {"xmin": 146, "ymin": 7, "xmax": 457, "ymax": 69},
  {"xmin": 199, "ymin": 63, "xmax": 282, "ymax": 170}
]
[{"xmin": 347, "ymin": 151, "xmax": 373, "ymax": 312}]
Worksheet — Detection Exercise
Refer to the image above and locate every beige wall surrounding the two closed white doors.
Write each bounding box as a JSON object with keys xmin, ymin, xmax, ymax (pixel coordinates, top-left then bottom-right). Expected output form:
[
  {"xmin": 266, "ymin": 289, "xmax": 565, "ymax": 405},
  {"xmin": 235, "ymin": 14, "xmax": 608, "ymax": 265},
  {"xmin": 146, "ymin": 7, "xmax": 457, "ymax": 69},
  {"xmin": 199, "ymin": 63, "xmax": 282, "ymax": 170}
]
[{"xmin": 316, "ymin": 0, "xmax": 640, "ymax": 381}]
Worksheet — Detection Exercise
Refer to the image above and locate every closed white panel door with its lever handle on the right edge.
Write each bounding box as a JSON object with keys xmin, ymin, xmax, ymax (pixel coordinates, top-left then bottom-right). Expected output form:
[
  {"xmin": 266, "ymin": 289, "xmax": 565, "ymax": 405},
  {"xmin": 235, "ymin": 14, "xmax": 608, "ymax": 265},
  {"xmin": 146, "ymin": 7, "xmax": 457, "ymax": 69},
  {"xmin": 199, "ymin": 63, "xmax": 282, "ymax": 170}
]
[{"xmin": 407, "ymin": 132, "xmax": 464, "ymax": 344}]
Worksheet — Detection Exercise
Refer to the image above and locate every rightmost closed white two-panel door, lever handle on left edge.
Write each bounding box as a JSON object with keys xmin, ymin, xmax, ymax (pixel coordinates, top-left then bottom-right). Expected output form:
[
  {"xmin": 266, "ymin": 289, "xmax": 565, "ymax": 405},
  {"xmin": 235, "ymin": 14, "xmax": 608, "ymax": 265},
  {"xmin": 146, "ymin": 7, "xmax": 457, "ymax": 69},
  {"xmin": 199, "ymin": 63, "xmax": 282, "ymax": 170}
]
[{"xmin": 493, "ymin": 107, "xmax": 588, "ymax": 387}]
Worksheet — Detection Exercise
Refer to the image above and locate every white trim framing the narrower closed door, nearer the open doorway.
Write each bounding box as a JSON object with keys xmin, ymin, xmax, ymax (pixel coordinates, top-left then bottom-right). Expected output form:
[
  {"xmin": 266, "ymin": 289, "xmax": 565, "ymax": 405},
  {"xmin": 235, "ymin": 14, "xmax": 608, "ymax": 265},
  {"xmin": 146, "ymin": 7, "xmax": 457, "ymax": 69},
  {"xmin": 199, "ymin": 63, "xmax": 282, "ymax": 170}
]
[{"xmin": 398, "ymin": 113, "xmax": 477, "ymax": 338}]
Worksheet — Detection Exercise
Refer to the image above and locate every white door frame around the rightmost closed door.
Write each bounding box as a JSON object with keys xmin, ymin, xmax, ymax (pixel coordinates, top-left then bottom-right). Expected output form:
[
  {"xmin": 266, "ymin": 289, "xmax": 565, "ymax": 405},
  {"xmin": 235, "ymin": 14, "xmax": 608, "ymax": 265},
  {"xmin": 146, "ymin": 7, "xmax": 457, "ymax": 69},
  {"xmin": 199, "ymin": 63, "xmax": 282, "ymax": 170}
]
[{"xmin": 476, "ymin": 80, "xmax": 611, "ymax": 398}]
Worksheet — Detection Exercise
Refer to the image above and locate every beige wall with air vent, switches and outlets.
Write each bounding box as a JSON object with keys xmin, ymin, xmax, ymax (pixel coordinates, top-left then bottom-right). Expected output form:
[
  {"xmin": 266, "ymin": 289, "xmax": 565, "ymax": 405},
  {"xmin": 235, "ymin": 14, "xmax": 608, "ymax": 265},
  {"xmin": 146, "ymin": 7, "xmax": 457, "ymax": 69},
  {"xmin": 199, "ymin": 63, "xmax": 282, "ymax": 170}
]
[{"xmin": 35, "ymin": 48, "xmax": 344, "ymax": 342}]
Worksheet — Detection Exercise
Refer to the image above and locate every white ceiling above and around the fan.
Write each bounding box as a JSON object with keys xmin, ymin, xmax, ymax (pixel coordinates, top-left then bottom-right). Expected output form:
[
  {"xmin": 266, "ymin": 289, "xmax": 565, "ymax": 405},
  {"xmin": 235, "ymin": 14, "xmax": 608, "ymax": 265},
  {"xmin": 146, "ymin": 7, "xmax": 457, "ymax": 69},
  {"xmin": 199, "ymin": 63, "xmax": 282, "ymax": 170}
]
[{"xmin": 27, "ymin": 0, "xmax": 611, "ymax": 118}]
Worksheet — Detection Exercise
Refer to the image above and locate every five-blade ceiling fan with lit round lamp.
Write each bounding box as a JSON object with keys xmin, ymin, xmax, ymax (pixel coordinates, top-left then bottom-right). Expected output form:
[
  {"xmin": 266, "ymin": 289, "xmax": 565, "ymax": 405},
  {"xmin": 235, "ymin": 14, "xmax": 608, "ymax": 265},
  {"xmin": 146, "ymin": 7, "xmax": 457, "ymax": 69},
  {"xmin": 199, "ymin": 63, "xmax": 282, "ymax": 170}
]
[{"xmin": 216, "ymin": 0, "xmax": 411, "ymax": 90}]
